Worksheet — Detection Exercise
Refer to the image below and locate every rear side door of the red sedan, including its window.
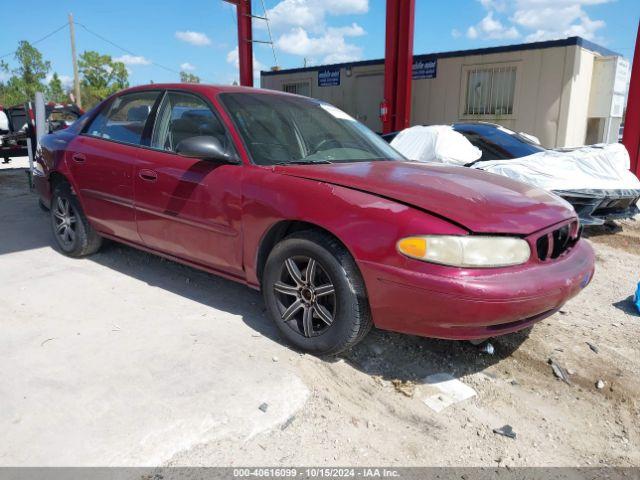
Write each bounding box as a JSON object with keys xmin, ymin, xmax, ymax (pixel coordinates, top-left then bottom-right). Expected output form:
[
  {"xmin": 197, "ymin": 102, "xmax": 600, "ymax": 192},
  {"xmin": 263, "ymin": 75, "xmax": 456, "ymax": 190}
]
[{"xmin": 65, "ymin": 90, "xmax": 160, "ymax": 243}]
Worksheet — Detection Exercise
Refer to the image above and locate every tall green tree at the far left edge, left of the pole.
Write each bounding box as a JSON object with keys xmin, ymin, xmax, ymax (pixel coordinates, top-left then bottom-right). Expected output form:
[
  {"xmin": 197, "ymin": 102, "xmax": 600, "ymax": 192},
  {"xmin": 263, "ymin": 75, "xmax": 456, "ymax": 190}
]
[{"xmin": 0, "ymin": 40, "xmax": 51, "ymax": 105}]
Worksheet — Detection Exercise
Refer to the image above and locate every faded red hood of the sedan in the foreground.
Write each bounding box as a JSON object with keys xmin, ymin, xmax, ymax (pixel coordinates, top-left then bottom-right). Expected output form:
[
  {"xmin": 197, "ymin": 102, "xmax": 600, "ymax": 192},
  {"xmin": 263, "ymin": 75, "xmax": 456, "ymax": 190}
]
[{"xmin": 274, "ymin": 161, "xmax": 576, "ymax": 235}]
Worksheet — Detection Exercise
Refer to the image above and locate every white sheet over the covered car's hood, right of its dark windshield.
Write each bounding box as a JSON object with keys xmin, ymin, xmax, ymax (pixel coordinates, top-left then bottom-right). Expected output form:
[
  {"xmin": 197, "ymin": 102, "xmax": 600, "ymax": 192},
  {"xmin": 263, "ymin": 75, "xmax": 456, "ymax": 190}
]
[{"xmin": 473, "ymin": 143, "xmax": 640, "ymax": 190}]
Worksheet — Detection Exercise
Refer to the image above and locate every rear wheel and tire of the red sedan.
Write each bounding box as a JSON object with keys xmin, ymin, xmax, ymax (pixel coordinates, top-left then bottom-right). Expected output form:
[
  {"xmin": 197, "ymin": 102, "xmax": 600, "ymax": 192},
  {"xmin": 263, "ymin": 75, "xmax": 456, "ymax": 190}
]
[{"xmin": 50, "ymin": 182, "xmax": 102, "ymax": 258}]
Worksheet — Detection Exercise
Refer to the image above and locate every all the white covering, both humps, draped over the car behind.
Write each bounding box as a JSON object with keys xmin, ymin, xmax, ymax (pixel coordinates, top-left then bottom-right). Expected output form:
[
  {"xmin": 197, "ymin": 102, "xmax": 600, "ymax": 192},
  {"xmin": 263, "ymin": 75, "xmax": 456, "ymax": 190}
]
[{"xmin": 391, "ymin": 125, "xmax": 640, "ymax": 190}]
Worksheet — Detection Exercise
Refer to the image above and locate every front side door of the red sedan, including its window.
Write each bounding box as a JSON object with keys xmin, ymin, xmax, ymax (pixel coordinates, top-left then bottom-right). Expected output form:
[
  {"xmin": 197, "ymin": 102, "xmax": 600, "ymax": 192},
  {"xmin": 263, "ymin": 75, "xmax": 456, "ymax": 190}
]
[{"xmin": 135, "ymin": 91, "xmax": 243, "ymax": 275}]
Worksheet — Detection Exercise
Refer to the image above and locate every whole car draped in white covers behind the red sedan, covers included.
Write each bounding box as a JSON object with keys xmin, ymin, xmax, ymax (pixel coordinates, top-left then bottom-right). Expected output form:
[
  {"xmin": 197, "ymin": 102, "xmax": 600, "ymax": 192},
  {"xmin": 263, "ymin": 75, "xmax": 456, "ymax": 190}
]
[{"xmin": 385, "ymin": 122, "xmax": 640, "ymax": 225}]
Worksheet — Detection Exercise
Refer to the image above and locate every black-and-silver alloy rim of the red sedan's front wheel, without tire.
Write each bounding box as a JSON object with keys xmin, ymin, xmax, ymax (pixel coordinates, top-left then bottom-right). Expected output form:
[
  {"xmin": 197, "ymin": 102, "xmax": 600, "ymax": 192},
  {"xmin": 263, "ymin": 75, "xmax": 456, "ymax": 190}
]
[{"xmin": 273, "ymin": 256, "xmax": 336, "ymax": 337}]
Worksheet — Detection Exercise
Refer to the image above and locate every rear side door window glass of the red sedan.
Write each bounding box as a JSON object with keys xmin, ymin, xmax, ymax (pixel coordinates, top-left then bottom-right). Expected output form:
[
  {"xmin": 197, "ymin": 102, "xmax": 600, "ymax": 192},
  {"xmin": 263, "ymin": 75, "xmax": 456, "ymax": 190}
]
[{"xmin": 86, "ymin": 91, "xmax": 160, "ymax": 145}]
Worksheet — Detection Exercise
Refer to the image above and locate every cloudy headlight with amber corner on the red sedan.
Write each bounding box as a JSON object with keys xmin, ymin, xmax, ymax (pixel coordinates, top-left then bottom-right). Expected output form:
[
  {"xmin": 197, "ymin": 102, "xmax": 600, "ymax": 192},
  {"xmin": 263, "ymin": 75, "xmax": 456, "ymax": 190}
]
[{"xmin": 396, "ymin": 235, "xmax": 531, "ymax": 268}]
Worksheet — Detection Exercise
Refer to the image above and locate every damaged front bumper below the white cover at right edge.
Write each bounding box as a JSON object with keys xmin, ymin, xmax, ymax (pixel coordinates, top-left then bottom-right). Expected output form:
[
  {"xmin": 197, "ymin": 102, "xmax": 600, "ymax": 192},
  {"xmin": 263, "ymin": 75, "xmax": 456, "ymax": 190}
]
[{"xmin": 553, "ymin": 189, "xmax": 640, "ymax": 225}]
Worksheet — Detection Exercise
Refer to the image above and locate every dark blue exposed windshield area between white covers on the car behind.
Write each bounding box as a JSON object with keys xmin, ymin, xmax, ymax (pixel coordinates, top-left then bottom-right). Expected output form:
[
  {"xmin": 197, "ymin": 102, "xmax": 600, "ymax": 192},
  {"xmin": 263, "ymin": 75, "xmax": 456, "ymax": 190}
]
[{"xmin": 453, "ymin": 123, "xmax": 544, "ymax": 161}]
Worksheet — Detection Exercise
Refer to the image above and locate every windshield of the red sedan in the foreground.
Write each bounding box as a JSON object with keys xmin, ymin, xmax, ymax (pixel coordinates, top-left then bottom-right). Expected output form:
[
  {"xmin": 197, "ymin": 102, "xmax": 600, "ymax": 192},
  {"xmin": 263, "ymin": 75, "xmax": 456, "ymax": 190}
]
[{"xmin": 220, "ymin": 93, "xmax": 404, "ymax": 165}]
